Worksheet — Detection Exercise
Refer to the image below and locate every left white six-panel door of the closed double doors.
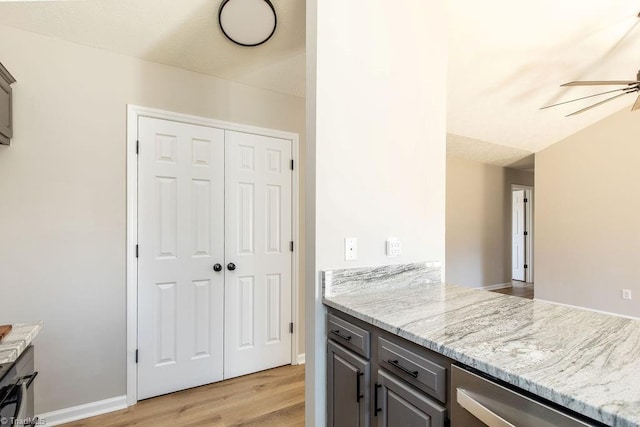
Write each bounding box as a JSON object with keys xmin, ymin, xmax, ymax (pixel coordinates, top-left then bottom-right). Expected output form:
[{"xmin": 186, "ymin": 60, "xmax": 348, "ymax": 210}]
[{"xmin": 138, "ymin": 118, "xmax": 224, "ymax": 399}]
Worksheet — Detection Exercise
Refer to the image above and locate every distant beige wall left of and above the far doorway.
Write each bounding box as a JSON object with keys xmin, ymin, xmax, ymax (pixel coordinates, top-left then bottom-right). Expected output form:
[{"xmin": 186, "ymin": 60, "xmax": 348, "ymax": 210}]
[{"xmin": 446, "ymin": 155, "xmax": 535, "ymax": 288}]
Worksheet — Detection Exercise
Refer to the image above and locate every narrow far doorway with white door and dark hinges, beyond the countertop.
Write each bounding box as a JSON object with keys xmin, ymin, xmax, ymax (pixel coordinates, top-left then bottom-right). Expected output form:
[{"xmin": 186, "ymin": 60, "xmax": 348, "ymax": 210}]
[{"xmin": 511, "ymin": 184, "xmax": 533, "ymax": 285}]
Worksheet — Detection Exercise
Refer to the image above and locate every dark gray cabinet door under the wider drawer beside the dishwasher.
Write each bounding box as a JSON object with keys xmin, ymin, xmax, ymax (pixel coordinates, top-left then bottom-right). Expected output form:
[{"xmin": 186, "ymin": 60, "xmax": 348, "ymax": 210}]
[{"xmin": 375, "ymin": 370, "xmax": 447, "ymax": 427}]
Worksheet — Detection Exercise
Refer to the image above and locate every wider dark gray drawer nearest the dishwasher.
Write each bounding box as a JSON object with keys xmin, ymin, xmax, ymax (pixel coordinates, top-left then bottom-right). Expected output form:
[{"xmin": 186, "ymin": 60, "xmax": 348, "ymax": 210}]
[{"xmin": 378, "ymin": 337, "xmax": 447, "ymax": 403}]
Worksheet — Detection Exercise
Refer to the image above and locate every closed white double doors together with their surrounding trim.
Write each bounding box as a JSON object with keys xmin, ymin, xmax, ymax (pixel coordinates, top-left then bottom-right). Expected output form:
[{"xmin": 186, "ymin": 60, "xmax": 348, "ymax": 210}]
[{"xmin": 127, "ymin": 107, "xmax": 298, "ymax": 404}]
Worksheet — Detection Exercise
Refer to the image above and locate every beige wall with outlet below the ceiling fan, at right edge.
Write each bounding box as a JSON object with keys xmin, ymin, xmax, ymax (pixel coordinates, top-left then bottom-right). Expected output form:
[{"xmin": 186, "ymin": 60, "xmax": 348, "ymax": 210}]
[{"xmin": 534, "ymin": 107, "xmax": 640, "ymax": 317}]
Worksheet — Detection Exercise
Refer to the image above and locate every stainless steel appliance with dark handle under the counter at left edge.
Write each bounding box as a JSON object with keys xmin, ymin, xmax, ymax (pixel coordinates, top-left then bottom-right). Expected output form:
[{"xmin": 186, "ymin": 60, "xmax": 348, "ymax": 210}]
[{"xmin": 0, "ymin": 346, "xmax": 38, "ymax": 427}]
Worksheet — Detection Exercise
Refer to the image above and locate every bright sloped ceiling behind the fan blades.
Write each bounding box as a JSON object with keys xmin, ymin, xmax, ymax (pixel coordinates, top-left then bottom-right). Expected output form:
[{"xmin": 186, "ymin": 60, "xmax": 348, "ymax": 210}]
[{"xmin": 447, "ymin": 0, "xmax": 640, "ymax": 152}]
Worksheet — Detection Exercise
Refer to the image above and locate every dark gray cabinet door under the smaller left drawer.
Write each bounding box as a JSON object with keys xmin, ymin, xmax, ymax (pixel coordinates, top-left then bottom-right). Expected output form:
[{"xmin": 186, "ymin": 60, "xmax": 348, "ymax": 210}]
[{"xmin": 327, "ymin": 340, "xmax": 370, "ymax": 427}]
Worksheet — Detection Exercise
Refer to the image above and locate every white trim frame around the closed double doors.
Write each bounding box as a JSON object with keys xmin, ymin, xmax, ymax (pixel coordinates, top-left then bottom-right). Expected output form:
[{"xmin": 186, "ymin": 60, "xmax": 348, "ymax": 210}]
[{"xmin": 126, "ymin": 104, "xmax": 302, "ymax": 406}]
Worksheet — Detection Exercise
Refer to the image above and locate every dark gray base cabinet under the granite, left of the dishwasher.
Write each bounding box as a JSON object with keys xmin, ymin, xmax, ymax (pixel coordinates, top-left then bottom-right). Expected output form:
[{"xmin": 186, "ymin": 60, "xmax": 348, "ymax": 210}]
[{"xmin": 327, "ymin": 309, "xmax": 451, "ymax": 427}]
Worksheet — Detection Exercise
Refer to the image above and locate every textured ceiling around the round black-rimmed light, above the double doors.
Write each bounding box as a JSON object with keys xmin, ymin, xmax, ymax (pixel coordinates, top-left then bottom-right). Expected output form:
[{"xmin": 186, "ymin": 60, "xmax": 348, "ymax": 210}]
[{"xmin": 0, "ymin": 0, "xmax": 305, "ymax": 96}]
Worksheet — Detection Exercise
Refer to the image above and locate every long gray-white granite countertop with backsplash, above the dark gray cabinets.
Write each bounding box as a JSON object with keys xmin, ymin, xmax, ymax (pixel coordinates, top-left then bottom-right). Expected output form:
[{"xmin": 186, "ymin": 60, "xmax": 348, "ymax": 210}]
[{"xmin": 324, "ymin": 266, "xmax": 640, "ymax": 427}]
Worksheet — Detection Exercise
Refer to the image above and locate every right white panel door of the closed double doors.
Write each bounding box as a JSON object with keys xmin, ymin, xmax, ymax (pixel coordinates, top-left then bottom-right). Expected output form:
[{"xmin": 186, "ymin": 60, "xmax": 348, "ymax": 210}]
[{"xmin": 224, "ymin": 131, "xmax": 292, "ymax": 378}]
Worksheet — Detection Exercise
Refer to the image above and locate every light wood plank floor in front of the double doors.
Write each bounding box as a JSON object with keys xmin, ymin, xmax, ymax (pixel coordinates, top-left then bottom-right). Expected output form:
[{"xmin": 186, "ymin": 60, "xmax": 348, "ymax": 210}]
[{"xmin": 64, "ymin": 365, "xmax": 304, "ymax": 427}]
